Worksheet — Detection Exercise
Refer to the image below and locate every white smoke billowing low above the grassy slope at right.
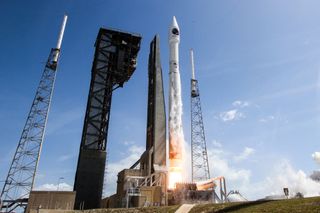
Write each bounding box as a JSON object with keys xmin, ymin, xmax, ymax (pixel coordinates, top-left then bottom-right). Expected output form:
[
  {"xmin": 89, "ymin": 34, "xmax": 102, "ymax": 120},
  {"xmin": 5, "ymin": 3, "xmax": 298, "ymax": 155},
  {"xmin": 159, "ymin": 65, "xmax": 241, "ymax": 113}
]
[{"xmin": 208, "ymin": 146, "xmax": 320, "ymax": 200}]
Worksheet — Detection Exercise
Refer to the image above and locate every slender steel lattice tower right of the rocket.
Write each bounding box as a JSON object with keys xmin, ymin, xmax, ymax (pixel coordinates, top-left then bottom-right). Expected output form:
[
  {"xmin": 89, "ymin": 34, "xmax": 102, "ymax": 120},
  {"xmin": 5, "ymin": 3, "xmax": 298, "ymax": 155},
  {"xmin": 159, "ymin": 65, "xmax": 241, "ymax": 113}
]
[{"xmin": 190, "ymin": 50, "xmax": 210, "ymax": 182}]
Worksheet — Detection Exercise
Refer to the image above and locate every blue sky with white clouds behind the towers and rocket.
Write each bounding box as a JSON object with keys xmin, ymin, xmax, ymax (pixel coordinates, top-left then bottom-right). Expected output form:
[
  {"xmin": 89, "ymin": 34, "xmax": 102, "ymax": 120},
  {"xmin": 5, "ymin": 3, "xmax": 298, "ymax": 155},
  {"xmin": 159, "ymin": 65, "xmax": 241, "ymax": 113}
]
[{"xmin": 0, "ymin": 0, "xmax": 320, "ymax": 199}]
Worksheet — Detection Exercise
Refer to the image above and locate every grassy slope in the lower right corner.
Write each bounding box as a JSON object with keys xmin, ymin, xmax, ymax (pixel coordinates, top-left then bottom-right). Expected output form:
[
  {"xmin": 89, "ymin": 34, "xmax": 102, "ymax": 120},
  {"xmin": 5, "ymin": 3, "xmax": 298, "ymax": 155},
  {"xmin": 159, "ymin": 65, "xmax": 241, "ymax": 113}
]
[{"xmin": 190, "ymin": 197, "xmax": 320, "ymax": 213}]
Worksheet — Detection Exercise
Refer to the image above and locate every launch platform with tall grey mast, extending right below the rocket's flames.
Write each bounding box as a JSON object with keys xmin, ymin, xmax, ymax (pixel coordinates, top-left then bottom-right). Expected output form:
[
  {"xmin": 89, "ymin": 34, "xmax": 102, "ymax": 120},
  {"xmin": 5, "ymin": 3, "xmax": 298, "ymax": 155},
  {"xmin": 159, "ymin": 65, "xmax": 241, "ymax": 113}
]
[{"xmin": 101, "ymin": 31, "xmax": 227, "ymax": 208}]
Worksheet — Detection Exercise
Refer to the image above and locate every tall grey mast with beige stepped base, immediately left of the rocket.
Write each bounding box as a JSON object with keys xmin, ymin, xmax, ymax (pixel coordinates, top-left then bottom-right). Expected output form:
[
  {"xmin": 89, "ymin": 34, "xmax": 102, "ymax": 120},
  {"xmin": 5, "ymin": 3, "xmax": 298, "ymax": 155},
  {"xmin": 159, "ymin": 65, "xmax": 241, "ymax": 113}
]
[{"xmin": 102, "ymin": 35, "xmax": 167, "ymax": 208}]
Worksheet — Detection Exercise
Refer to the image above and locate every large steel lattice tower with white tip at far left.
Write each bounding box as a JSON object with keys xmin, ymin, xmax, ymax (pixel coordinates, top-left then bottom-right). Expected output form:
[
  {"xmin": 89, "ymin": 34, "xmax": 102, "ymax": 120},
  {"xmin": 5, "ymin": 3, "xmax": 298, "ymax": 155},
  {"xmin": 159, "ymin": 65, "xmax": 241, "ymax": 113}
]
[{"xmin": 0, "ymin": 16, "xmax": 67, "ymax": 212}]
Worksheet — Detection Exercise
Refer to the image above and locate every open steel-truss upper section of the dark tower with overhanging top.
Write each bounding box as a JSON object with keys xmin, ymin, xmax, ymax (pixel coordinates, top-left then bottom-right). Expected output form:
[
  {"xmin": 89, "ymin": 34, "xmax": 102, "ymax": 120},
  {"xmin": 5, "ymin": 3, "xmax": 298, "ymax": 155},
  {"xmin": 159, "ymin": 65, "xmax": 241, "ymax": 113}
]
[{"xmin": 81, "ymin": 28, "xmax": 141, "ymax": 150}]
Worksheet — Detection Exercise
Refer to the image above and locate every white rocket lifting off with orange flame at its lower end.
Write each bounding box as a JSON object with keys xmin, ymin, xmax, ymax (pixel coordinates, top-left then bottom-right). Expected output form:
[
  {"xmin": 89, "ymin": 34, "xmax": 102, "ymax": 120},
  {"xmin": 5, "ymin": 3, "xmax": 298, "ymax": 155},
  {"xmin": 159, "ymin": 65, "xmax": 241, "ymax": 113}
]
[{"xmin": 169, "ymin": 17, "xmax": 184, "ymax": 163}]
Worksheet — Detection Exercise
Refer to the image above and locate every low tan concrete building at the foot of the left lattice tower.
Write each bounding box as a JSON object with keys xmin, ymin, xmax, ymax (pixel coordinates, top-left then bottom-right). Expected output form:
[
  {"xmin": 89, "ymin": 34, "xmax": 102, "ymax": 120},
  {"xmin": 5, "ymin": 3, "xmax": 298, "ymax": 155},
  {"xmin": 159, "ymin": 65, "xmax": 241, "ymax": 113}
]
[{"xmin": 26, "ymin": 191, "xmax": 76, "ymax": 213}]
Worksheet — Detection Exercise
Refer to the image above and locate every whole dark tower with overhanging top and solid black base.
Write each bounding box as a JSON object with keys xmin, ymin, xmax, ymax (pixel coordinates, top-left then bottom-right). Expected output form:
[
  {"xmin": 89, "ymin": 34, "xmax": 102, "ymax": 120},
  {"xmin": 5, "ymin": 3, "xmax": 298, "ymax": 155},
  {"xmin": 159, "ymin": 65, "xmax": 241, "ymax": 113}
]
[{"xmin": 74, "ymin": 28, "xmax": 141, "ymax": 209}]
